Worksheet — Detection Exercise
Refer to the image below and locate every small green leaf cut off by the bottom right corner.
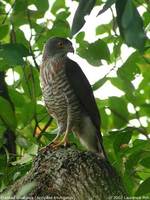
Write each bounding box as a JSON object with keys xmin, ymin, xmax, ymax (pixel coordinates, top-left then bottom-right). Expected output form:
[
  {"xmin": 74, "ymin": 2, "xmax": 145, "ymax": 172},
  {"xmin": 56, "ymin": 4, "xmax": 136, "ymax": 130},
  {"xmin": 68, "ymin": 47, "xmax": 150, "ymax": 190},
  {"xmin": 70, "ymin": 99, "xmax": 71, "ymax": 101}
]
[{"xmin": 135, "ymin": 178, "xmax": 150, "ymax": 196}]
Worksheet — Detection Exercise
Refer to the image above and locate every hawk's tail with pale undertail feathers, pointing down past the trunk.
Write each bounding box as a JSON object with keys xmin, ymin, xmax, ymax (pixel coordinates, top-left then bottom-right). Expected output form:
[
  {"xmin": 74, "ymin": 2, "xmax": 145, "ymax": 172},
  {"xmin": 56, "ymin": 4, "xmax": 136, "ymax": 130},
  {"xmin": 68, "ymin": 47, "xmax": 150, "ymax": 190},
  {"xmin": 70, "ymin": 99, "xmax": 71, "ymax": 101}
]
[{"xmin": 78, "ymin": 116, "xmax": 107, "ymax": 160}]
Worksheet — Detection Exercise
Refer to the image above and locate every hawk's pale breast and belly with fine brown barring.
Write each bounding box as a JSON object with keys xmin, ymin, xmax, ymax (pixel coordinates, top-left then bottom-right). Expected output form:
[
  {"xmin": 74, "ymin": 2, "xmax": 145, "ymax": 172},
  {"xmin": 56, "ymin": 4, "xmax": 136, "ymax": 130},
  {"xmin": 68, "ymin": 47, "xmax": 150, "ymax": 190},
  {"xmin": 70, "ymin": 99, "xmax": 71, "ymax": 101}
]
[{"xmin": 41, "ymin": 58, "xmax": 81, "ymax": 131}]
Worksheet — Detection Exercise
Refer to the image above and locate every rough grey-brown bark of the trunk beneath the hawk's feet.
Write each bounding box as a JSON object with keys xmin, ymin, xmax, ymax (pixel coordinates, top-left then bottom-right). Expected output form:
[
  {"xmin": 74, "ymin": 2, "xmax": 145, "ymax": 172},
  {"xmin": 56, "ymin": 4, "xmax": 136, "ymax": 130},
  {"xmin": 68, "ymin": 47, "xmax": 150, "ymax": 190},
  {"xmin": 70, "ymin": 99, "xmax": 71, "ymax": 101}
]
[{"xmin": 8, "ymin": 147, "xmax": 126, "ymax": 200}]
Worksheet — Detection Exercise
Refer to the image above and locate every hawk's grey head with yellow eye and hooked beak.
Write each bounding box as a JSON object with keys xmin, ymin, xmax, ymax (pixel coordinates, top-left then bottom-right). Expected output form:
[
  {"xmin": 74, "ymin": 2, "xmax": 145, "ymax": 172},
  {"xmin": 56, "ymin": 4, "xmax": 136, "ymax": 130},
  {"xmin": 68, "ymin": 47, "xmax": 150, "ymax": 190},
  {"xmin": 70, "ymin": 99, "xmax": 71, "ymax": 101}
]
[{"xmin": 43, "ymin": 37, "xmax": 74, "ymax": 59}]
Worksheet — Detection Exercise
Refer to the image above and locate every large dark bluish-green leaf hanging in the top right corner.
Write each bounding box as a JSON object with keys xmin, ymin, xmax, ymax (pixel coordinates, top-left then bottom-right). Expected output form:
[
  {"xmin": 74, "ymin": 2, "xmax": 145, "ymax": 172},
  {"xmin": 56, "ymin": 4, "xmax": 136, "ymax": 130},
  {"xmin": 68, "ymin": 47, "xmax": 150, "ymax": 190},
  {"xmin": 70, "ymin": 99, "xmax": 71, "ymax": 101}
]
[{"xmin": 116, "ymin": 0, "xmax": 146, "ymax": 51}]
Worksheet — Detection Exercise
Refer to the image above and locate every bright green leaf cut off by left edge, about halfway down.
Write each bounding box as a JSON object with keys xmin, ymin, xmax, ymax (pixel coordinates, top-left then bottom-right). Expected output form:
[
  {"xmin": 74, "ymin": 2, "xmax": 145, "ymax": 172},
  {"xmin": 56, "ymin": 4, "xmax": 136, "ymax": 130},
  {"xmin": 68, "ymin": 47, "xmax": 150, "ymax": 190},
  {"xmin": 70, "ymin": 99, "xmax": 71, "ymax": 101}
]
[{"xmin": 0, "ymin": 96, "xmax": 17, "ymax": 131}]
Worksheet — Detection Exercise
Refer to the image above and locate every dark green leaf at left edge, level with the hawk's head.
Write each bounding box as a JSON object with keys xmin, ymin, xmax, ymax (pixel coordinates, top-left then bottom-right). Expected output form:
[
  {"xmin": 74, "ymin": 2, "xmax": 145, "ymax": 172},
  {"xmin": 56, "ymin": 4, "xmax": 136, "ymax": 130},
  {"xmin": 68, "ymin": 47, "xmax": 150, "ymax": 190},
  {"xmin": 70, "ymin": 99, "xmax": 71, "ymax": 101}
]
[{"xmin": 0, "ymin": 44, "xmax": 30, "ymax": 70}]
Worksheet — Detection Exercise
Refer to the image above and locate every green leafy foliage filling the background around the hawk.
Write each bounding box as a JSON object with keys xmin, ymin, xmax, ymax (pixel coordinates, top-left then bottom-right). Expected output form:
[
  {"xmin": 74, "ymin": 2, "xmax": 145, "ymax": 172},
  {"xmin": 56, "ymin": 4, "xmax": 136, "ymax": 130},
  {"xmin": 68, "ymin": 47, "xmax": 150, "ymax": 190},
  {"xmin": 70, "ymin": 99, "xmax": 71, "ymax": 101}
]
[{"xmin": 0, "ymin": 0, "xmax": 150, "ymax": 197}]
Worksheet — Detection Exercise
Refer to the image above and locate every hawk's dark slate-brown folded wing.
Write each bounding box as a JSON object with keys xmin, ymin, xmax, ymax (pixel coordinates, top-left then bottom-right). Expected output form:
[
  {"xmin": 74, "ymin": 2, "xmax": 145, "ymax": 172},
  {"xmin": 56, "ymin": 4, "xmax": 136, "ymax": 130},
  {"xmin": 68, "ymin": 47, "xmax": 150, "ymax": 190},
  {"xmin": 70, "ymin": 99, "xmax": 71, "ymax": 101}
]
[{"xmin": 65, "ymin": 59, "xmax": 100, "ymax": 131}]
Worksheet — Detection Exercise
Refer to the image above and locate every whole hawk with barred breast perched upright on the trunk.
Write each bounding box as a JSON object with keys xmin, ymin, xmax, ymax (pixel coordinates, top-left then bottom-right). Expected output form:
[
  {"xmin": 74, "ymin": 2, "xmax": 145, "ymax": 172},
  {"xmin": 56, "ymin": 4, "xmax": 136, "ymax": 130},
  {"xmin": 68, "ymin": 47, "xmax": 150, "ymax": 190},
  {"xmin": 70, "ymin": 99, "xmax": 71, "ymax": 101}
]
[{"xmin": 40, "ymin": 37, "xmax": 107, "ymax": 159}]
